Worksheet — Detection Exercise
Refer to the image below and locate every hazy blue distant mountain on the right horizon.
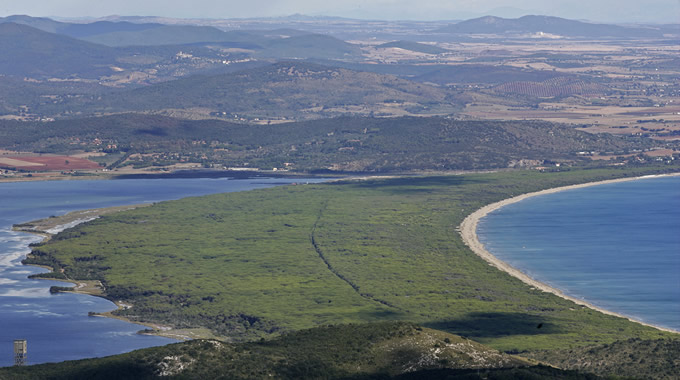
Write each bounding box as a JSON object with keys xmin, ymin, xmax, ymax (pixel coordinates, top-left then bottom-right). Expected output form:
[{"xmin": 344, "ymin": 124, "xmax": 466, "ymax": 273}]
[{"xmin": 438, "ymin": 16, "xmax": 663, "ymax": 38}]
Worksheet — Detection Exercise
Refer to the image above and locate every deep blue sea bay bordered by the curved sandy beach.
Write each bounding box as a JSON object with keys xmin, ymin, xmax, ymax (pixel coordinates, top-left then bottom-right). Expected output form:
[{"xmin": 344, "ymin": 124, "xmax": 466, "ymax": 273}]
[{"xmin": 477, "ymin": 177, "xmax": 680, "ymax": 331}]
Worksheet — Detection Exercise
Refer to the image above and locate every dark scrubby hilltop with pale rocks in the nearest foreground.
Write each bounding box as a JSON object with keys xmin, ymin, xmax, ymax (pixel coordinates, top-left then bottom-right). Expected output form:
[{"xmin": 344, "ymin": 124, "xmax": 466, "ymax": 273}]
[{"xmin": 0, "ymin": 323, "xmax": 595, "ymax": 380}]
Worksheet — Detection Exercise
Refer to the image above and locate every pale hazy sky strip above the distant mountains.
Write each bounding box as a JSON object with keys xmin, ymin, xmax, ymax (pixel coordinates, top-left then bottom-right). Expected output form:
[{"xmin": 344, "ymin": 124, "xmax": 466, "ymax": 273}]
[{"xmin": 0, "ymin": 0, "xmax": 680, "ymax": 23}]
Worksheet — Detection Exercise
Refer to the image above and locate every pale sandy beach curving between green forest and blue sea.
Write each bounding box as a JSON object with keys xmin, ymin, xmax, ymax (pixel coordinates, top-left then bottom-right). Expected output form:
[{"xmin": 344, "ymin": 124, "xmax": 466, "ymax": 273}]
[{"xmin": 459, "ymin": 173, "xmax": 680, "ymax": 334}]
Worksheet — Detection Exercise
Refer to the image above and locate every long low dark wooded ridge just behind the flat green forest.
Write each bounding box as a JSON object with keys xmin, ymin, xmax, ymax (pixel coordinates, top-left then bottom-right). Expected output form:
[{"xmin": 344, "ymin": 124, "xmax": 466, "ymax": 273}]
[{"xmin": 0, "ymin": 114, "xmax": 658, "ymax": 172}]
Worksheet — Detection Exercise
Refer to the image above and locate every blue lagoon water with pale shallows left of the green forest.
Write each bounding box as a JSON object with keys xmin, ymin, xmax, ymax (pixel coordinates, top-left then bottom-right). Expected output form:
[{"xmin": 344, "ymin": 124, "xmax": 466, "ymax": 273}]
[{"xmin": 0, "ymin": 178, "xmax": 321, "ymax": 366}]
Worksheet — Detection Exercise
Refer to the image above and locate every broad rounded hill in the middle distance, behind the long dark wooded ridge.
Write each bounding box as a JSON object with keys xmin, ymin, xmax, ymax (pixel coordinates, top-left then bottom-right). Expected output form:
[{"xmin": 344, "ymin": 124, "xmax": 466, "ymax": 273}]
[{"xmin": 81, "ymin": 61, "xmax": 455, "ymax": 119}]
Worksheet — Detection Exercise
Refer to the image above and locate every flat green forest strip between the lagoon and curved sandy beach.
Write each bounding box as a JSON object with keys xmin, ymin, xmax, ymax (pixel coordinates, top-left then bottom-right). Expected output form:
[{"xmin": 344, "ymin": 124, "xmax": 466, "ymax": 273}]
[{"xmin": 27, "ymin": 167, "xmax": 670, "ymax": 352}]
